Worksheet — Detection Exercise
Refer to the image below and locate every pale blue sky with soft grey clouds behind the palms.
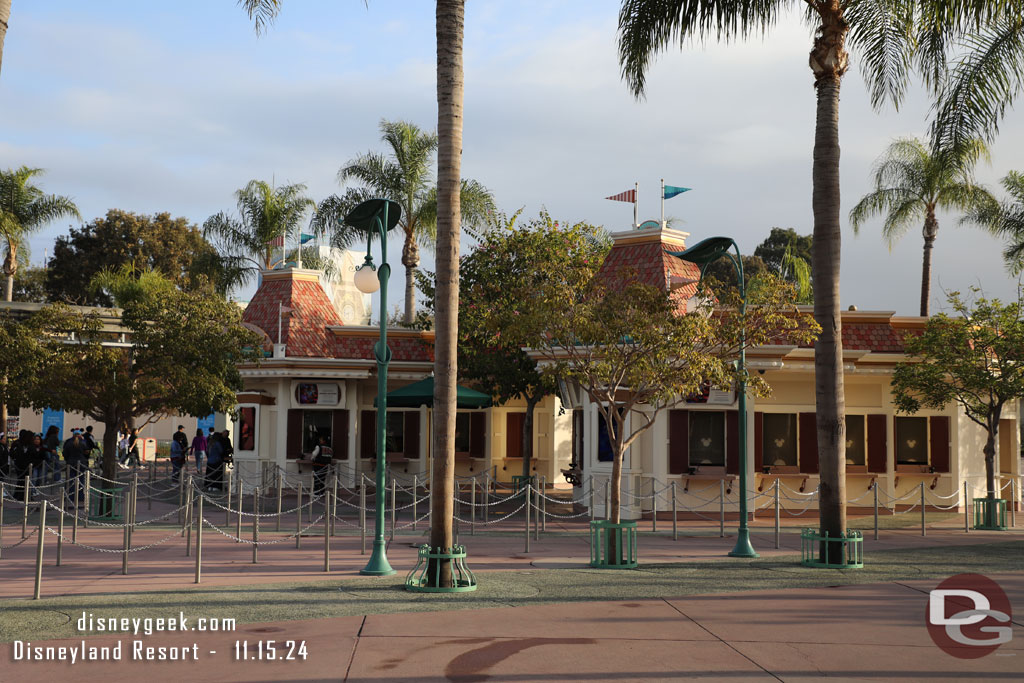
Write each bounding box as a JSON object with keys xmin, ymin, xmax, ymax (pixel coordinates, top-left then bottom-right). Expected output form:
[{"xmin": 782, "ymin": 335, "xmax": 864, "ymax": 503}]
[{"xmin": 0, "ymin": 0, "xmax": 1024, "ymax": 315}]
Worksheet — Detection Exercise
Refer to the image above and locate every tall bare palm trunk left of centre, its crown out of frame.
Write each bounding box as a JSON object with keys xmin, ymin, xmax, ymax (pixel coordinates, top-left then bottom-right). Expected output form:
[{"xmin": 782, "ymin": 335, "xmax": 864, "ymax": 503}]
[{"xmin": 430, "ymin": 0, "xmax": 466, "ymax": 586}]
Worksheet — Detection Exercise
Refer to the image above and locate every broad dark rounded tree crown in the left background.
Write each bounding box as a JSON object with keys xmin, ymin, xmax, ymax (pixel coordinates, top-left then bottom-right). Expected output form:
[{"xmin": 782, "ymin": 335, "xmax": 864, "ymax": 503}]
[{"xmin": 46, "ymin": 209, "xmax": 216, "ymax": 306}]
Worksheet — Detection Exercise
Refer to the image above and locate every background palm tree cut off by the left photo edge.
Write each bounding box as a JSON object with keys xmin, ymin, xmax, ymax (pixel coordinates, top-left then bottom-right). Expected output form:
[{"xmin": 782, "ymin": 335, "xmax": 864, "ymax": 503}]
[{"xmin": 0, "ymin": 166, "xmax": 81, "ymax": 301}]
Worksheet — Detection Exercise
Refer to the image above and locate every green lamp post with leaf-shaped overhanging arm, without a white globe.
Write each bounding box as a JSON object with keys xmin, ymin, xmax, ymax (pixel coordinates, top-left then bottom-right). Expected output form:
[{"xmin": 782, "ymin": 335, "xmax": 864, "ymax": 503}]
[{"xmin": 669, "ymin": 238, "xmax": 759, "ymax": 557}]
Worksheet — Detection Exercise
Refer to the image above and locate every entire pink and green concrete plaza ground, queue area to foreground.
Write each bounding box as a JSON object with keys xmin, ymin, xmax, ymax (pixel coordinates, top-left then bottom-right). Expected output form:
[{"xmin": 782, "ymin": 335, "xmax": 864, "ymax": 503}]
[{"xmin": 0, "ymin": 489, "xmax": 1024, "ymax": 683}]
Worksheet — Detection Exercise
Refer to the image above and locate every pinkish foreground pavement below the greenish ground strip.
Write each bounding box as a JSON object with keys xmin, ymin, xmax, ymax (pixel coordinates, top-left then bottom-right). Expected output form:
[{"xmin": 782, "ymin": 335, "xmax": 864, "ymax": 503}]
[{"xmin": 0, "ymin": 573, "xmax": 1024, "ymax": 683}]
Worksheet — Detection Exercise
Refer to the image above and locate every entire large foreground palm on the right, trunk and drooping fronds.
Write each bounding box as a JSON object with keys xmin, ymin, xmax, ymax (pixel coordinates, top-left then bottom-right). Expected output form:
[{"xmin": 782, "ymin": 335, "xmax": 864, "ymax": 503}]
[{"xmin": 618, "ymin": 0, "xmax": 1010, "ymax": 552}]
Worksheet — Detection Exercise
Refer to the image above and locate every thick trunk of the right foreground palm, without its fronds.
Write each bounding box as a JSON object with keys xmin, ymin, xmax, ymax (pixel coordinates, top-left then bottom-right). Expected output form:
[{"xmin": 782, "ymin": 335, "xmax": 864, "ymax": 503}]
[{"xmin": 810, "ymin": 6, "xmax": 849, "ymax": 561}]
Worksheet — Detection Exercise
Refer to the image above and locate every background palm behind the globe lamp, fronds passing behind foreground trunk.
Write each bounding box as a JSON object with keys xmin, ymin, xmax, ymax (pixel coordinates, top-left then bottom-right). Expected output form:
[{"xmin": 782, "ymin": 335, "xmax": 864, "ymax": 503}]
[{"xmin": 316, "ymin": 120, "xmax": 494, "ymax": 325}]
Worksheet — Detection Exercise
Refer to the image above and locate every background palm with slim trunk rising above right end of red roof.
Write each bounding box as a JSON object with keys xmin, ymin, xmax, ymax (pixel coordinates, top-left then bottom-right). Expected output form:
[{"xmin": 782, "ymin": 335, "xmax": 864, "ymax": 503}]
[{"xmin": 850, "ymin": 137, "xmax": 995, "ymax": 316}]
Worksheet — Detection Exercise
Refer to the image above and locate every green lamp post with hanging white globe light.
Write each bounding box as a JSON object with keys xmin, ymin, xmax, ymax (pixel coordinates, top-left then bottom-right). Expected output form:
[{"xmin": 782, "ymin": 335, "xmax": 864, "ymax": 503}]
[{"xmin": 345, "ymin": 200, "xmax": 401, "ymax": 577}]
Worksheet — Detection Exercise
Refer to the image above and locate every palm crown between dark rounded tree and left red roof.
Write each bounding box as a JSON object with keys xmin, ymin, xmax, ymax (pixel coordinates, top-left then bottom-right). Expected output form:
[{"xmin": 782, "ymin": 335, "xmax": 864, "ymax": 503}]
[{"xmin": 203, "ymin": 180, "xmax": 316, "ymax": 289}]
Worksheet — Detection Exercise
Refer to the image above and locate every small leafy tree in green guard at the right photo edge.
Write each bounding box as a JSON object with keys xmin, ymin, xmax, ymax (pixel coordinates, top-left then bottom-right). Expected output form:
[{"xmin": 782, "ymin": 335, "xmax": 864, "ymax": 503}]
[{"xmin": 892, "ymin": 289, "xmax": 1024, "ymax": 525}]
